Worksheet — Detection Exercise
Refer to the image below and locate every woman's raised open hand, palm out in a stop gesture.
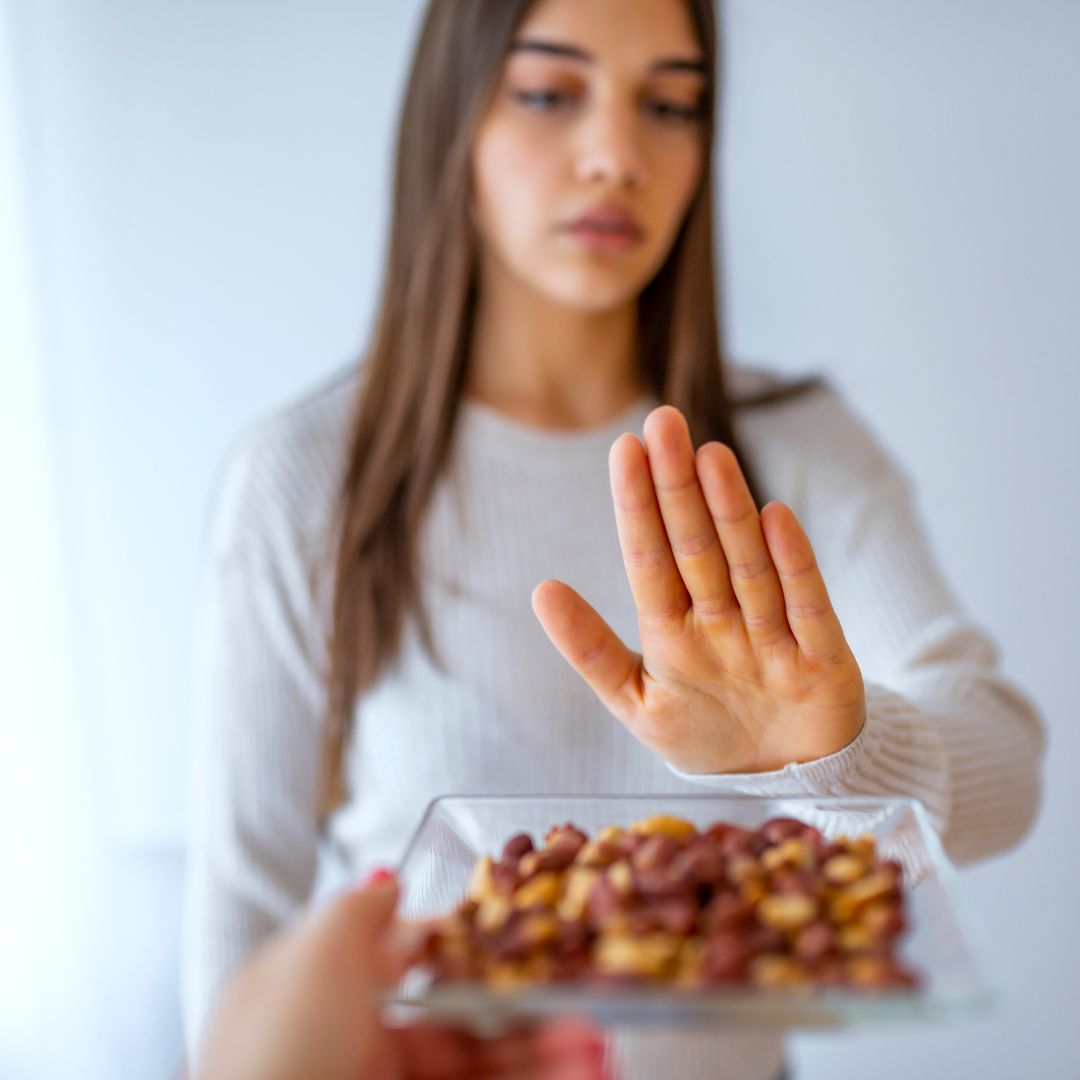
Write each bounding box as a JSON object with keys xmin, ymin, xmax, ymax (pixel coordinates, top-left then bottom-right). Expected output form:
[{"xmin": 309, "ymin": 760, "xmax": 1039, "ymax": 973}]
[{"xmin": 532, "ymin": 405, "xmax": 865, "ymax": 773}]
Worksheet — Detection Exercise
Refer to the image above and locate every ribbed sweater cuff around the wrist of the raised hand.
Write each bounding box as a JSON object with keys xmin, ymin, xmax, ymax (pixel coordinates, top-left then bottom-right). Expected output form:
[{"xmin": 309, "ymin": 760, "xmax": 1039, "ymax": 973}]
[{"xmin": 667, "ymin": 683, "xmax": 948, "ymax": 832}]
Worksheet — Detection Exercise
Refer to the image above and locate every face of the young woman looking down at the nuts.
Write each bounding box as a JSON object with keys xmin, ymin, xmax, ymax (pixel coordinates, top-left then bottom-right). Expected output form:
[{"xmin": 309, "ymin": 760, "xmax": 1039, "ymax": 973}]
[{"xmin": 472, "ymin": 0, "xmax": 711, "ymax": 311}]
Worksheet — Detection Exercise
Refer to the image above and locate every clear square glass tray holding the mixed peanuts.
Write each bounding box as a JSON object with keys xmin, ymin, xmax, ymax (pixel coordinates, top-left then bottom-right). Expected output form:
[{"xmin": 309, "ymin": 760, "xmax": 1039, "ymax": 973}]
[{"xmin": 388, "ymin": 795, "xmax": 997, "ymax": 1034}]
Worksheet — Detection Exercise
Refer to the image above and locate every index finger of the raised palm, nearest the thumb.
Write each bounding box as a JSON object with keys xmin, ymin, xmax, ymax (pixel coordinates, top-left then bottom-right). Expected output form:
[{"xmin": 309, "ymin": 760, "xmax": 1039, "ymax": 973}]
[{"xmin": 608, "ymin": 432, "xmax": 690, "ymax": 621}]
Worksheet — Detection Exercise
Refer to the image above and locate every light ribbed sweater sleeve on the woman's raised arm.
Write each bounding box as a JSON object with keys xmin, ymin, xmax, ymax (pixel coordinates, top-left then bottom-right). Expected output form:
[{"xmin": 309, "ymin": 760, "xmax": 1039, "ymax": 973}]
[{"xmin": 675, "ymin": 393, "xmax": 1044, "ymax": 863}]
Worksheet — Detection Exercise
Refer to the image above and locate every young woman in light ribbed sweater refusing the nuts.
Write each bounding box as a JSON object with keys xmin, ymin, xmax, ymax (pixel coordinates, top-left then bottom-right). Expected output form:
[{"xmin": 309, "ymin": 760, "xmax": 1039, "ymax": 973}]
[{"xmin": 185, "ymin": 0, "xmax": 1042, "ymax": 1080}]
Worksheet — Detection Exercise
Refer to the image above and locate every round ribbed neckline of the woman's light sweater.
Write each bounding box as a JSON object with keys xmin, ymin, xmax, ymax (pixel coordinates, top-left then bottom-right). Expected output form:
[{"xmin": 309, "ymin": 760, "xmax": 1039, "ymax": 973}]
[{"xmin": 458, "ymin": 392, "xmax": 660, "ymax": 456}]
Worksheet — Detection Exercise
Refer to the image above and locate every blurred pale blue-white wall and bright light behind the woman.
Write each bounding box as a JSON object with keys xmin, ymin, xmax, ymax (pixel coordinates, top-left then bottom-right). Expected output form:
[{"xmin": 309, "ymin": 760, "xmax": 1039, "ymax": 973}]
[{"xmin": 0, "ymin": 0, "xmax": 1080, "ymax": 1080}]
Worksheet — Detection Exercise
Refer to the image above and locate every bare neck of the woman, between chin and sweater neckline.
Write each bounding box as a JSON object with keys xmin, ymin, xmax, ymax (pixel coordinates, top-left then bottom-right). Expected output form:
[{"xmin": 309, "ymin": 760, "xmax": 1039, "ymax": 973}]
[{"xmin": 464, "ymin": 261, "xmax": 643, "ymax": 428}]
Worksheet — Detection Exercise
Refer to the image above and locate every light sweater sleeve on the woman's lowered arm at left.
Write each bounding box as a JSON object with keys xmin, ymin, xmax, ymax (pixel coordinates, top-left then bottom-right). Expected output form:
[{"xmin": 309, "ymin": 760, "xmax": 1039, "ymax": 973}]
[{"xmin": 181, "ymin": 436, "xmax": 325, "ymax": 1062}]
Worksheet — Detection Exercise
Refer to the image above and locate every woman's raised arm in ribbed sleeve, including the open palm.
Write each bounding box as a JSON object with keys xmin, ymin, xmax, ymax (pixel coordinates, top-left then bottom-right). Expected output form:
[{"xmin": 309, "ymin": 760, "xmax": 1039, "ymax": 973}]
[{"xmin": 532, "ymin": 392, "xmax": 1043, "ymax": 861}]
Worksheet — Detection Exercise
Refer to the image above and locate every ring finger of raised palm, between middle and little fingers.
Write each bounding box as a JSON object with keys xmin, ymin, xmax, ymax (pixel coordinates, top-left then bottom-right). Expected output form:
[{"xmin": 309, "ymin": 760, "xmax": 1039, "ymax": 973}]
[{"xmin": 698, "ymin": 443, "xmax": 791, "ymax": 648}]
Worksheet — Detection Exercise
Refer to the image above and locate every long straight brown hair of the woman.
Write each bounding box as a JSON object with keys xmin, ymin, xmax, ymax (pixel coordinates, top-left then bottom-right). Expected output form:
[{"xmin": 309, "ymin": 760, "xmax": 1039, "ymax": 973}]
[{"xmin": 323, "ymin": 0, "xmax": 819, "ymax": 812}]
